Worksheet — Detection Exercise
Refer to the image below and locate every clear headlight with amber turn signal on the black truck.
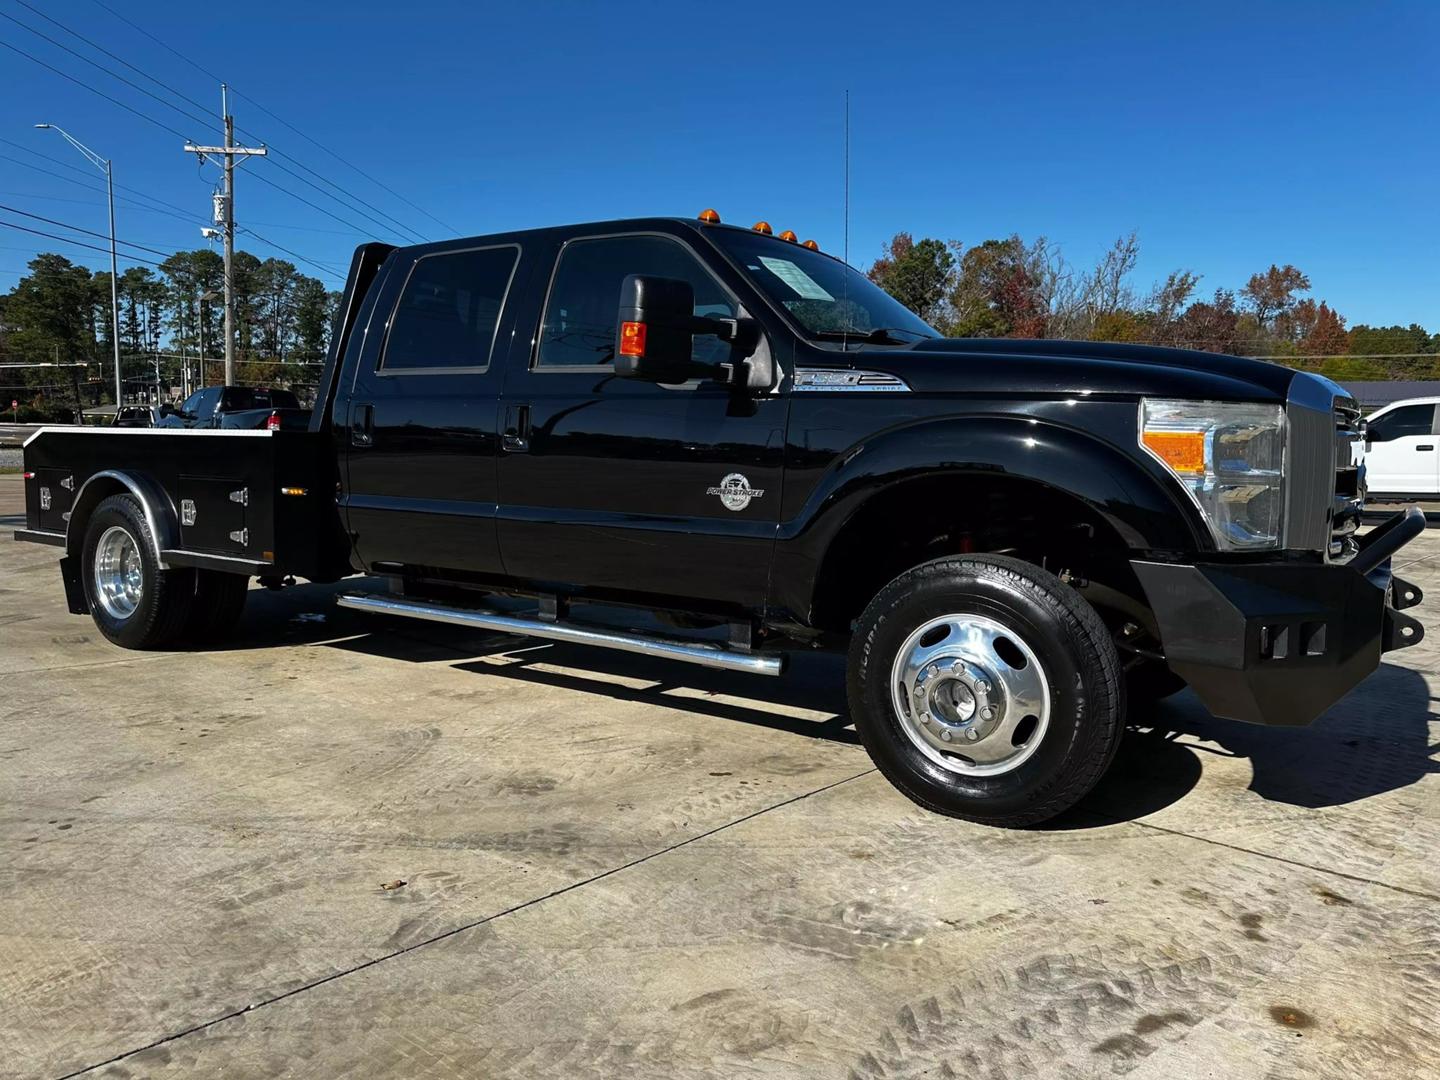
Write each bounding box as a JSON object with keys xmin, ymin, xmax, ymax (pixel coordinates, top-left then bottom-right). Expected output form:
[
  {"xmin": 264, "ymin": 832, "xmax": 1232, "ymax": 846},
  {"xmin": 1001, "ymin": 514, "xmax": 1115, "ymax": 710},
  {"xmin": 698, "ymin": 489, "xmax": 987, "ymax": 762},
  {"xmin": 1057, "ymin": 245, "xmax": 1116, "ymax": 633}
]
[{"xmin": 1140, "ymin": 397, "xmax": 1284, "ymax": 552}]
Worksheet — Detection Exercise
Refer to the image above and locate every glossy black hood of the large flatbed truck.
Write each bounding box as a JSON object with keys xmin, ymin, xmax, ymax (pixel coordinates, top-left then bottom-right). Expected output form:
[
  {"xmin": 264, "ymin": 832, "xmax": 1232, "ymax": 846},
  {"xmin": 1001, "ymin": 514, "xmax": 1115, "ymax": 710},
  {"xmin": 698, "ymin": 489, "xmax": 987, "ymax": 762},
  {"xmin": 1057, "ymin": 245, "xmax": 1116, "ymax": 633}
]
[{"xmin": 845, "ymin": 338, "xmax": 1307, "ymax": 402}]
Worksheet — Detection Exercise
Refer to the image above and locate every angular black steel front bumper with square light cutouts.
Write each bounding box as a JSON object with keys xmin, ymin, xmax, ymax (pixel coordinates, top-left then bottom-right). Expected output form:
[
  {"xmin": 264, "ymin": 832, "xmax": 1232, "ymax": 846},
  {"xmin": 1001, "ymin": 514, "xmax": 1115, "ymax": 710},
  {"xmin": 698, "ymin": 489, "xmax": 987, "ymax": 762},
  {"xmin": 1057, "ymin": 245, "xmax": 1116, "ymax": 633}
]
[{"xmin": 1132, "ymin": 507, "xmax": 1426, "ymax": 726}]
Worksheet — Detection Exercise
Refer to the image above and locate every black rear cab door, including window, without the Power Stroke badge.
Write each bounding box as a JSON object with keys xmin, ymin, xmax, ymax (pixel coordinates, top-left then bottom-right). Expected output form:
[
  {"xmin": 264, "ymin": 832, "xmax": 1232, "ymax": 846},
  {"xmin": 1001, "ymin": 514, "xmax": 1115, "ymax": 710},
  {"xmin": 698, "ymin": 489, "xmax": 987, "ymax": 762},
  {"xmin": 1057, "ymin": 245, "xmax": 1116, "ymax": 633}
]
[{"xmin": 341, "ymin": 243, "xmax": 521, "ymax": 573}]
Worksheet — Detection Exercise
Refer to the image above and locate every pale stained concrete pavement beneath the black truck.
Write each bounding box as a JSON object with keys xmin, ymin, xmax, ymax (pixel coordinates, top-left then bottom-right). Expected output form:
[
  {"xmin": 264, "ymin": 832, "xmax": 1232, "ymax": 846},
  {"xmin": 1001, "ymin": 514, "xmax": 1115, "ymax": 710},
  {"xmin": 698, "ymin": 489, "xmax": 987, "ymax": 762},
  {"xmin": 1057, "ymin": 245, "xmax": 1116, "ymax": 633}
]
[{"xmin": 0, "ymin": 477, "xmax": 1440, "ymax": 1080}]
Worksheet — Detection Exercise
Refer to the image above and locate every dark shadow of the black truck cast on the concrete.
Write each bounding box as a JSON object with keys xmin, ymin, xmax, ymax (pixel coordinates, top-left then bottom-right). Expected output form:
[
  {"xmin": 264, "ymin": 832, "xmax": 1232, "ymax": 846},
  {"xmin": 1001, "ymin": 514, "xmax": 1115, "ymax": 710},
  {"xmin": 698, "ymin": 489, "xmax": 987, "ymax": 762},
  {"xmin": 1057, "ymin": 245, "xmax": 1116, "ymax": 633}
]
[{"xmin": 230, "ymin": 580, "xmax": 1440, "ymax": 829}]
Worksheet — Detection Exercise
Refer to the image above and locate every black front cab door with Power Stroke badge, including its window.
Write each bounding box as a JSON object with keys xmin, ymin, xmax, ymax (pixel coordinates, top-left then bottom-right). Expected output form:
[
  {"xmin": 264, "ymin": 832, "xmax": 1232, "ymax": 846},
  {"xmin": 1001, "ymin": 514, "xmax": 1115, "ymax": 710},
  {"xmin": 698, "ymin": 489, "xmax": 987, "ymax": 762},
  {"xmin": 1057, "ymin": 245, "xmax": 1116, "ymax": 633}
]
[{"xmin": 498, "ymin": 233, "xmax": 786, "ymax": 608}]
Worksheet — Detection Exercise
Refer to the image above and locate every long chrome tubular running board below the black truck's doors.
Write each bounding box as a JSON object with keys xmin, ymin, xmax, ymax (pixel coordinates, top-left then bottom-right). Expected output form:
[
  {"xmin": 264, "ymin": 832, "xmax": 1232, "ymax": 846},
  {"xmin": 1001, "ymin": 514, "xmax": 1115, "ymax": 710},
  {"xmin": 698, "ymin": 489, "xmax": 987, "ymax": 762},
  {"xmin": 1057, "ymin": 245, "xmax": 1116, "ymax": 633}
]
[{"xmin": 336, "ymin": 593, "xmax": 785, "ymax": 675}]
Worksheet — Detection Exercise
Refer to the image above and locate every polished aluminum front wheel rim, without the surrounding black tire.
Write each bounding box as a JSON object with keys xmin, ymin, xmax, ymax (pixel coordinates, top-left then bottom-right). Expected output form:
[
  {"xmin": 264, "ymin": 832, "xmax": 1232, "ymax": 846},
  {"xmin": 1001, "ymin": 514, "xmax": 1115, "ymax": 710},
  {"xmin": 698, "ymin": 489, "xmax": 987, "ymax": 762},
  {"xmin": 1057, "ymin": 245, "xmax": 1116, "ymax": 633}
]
[{"xmin": 890, "ymin": 615, "xmax": 1050, "ymax": 776}]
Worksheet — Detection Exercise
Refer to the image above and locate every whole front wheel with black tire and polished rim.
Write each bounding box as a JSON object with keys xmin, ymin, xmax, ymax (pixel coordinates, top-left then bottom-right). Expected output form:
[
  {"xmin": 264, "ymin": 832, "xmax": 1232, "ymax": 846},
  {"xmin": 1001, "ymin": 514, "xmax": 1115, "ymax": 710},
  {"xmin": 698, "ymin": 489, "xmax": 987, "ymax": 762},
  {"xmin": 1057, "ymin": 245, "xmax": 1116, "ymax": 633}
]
[{"xmin": 847, "ymin": 556, "xmax": 1125, "ymax": 828}]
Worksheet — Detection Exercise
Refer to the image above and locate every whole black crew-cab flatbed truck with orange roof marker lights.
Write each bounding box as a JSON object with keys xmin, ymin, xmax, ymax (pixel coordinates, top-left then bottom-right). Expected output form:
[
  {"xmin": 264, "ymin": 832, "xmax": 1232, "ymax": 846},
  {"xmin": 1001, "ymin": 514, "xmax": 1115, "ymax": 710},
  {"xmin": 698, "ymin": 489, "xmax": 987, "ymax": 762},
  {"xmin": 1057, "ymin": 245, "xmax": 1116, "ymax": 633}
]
[{"xmin": 17, "ymin": 212, "xmax": 1424, "ymax": 825}]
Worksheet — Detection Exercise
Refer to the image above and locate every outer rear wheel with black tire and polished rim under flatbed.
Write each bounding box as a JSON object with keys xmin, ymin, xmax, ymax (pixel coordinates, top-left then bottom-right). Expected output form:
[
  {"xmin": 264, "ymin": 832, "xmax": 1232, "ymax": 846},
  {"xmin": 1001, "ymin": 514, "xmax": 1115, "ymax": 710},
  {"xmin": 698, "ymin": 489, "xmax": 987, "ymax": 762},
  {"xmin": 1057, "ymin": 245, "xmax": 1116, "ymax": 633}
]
[{"xmin": 81, "ymin": 495, "xmax": 194, "ymax": 649}]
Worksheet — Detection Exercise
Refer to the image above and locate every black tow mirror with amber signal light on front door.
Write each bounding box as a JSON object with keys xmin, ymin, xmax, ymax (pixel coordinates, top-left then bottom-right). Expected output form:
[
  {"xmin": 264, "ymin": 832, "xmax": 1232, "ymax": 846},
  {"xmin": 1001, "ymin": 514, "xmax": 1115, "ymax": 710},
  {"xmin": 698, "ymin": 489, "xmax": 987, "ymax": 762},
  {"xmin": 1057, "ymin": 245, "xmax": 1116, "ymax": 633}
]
[{"xmin": 615, "ymin": 274, "xmax": 759, "ymax": 383}]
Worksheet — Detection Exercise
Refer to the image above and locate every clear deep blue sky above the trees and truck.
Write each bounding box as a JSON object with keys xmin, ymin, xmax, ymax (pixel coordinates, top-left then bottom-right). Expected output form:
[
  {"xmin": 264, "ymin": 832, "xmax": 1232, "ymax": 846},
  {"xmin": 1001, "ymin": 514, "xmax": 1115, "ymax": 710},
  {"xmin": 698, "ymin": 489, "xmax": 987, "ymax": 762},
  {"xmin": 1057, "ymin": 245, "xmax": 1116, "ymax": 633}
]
[{"xmin": 0, "ymin": 0, "xmax": 1440, "ymax": 331}]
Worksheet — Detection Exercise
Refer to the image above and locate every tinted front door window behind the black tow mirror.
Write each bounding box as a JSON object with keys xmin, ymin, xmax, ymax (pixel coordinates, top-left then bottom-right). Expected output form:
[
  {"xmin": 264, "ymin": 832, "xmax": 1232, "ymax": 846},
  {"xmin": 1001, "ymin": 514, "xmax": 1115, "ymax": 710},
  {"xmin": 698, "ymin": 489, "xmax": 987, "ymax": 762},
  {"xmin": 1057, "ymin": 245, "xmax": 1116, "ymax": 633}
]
[{"xmin": 536, "ymin": 236, "xmax": 736, "ymax": 370}]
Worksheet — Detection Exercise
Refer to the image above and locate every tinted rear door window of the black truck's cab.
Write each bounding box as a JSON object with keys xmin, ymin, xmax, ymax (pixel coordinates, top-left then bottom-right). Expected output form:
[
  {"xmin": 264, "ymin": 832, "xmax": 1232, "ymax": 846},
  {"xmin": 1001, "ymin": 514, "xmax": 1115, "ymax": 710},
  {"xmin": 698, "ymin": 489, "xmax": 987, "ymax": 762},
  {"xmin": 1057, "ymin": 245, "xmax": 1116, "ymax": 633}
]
[{"xmin": 380, "ymin": 246, "xmax": 520, "ymax": 373}]
